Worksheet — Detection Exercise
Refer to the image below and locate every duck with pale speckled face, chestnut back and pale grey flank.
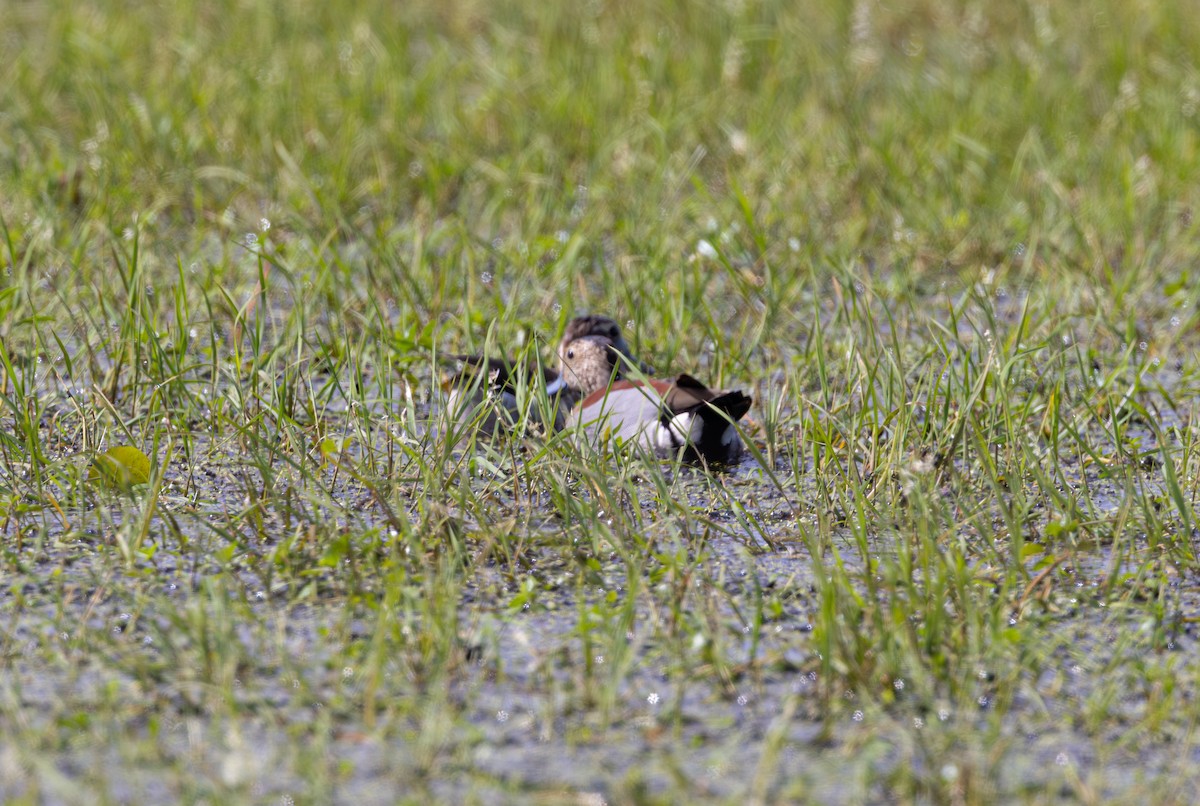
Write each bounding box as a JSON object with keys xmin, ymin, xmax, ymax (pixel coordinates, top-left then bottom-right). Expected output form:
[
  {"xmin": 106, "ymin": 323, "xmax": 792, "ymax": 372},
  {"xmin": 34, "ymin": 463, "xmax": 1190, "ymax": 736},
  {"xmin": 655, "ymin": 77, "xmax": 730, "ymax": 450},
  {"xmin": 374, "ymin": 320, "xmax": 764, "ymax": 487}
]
[{"xmin": 558, "ymin": 331, "xmax": 754, "ymax": 465}]
